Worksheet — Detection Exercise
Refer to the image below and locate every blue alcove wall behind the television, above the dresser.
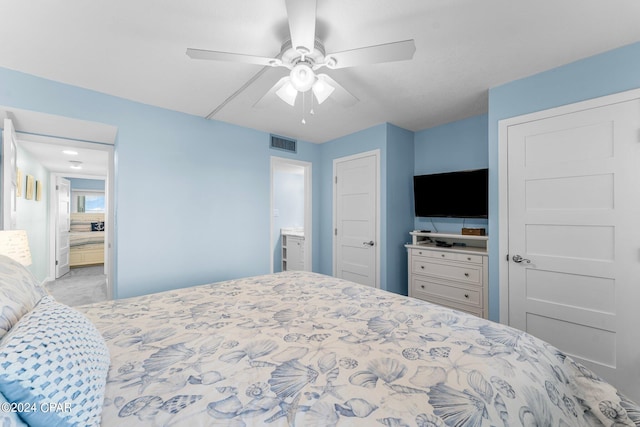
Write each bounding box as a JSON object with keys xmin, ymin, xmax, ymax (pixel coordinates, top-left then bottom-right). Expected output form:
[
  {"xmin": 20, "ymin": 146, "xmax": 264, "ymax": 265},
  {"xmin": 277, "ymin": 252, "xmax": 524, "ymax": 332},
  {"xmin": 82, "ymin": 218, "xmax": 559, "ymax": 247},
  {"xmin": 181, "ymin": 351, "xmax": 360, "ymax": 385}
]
[{"xmin": 411, "ymin": 114, "xmax": 489, "ymax": 233}]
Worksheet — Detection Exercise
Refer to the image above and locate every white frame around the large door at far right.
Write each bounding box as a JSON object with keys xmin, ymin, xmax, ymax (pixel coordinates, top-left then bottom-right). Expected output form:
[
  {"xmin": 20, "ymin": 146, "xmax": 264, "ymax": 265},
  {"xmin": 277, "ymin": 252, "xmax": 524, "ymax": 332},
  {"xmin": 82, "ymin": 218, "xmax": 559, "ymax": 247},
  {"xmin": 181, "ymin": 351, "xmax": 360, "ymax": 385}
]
[{"xmin": 498, "ymin": 89, "xmax": 640, "ymax": 325}]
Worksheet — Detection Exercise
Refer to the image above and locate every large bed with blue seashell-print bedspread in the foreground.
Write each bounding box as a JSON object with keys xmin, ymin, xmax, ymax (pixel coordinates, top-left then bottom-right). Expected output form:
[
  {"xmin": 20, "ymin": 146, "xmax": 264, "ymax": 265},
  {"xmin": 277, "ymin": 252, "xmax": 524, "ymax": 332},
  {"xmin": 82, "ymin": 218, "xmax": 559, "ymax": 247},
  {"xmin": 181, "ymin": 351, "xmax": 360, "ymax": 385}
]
[{"xmin": 0, "ymin": 257, "xmax": 640, "ymax": 427}]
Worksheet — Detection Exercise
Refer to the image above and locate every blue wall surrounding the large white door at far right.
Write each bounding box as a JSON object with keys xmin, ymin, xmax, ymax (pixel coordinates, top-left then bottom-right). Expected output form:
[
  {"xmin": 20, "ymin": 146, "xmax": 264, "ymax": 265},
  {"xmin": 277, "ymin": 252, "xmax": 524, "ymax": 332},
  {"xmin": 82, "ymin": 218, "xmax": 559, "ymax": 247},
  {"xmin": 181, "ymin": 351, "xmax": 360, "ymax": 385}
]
[{"xmin": 488, "ymin": 43, "xmax": 640, "ymax": 320}]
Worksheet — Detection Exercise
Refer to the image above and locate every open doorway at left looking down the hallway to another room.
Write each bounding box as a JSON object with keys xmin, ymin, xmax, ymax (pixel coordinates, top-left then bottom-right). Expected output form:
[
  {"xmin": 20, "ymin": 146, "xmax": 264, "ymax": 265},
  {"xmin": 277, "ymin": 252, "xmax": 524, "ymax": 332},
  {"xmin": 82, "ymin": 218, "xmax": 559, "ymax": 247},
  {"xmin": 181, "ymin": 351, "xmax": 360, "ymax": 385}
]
[{"xmin": 18, "ymin": 135, "xmax": 113, "ymax": 305}]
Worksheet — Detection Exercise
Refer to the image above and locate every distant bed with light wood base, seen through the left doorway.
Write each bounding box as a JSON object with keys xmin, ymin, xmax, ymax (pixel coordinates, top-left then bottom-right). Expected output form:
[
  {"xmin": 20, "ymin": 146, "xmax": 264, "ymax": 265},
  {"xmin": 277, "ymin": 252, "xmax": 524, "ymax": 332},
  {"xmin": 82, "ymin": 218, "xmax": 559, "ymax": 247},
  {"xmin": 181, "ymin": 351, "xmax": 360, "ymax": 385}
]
[{"xmin": 69, "ymin": 213, "xmax": 104, "ymax": 267}]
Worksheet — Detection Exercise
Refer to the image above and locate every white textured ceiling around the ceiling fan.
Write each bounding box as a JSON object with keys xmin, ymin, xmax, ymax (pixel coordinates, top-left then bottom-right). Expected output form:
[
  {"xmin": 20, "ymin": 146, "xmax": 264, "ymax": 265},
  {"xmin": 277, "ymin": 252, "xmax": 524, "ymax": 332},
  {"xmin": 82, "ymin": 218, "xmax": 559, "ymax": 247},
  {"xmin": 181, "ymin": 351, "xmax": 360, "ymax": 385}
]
[{"xmin": 0, "ymin": 0, "xmax": 640, "ymax": 147}]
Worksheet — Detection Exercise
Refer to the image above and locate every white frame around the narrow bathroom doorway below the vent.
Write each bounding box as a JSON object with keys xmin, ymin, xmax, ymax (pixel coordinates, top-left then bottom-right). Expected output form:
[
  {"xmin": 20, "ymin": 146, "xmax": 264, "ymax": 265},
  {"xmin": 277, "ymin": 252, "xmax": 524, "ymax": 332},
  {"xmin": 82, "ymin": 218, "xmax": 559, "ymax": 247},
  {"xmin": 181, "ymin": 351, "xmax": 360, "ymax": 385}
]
[{"xmin": 269, "ymin": 156, "xmax": 313, "ymax": 273}]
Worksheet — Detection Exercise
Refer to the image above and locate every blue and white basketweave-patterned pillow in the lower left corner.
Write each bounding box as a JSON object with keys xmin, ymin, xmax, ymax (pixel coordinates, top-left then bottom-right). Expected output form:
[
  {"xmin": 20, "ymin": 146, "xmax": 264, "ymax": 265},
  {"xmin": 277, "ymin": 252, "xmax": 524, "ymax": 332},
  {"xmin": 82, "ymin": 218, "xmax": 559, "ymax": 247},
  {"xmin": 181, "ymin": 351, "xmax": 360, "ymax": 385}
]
[{"xmin": 0, "ymin": 296, "xmax": 110, "ymax": 427}]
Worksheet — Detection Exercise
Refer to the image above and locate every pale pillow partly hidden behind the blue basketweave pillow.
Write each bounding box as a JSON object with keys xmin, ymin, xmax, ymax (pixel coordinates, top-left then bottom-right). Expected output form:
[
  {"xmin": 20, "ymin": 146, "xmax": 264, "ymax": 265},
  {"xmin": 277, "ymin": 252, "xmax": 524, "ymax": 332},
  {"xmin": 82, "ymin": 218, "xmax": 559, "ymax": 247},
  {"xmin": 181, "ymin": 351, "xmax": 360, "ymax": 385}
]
[{"xmin": 0, "ymin": 255, "xmax": 47, "ymax": 338}]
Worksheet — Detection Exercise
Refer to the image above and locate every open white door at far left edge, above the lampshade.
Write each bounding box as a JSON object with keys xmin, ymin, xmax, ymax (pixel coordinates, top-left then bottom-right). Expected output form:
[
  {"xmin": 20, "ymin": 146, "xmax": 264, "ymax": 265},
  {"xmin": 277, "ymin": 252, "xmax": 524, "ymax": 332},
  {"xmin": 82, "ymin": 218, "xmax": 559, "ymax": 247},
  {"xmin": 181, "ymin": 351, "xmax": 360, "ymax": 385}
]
[{"xmin": 0, "ymin": 119, "xmax": 18, "ymax": 230}]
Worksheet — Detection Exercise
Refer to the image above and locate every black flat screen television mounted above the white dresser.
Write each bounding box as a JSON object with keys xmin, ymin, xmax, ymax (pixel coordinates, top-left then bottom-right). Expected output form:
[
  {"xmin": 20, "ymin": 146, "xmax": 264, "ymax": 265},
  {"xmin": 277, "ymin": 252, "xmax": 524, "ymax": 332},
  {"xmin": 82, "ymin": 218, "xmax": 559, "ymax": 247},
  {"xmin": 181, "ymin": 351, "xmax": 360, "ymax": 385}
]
[{"xmin": 413, "ymin": 169, "xmax": 489, "ymax": 218}]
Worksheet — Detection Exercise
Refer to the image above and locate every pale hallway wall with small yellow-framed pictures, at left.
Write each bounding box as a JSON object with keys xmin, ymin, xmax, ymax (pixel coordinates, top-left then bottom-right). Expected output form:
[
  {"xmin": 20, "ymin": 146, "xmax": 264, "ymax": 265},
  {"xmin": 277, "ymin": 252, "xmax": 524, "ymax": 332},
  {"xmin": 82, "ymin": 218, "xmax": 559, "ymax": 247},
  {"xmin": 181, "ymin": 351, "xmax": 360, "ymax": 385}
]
[{"xmin": 16, "ymin": 147, "xmax": 49, "ymax": 281}]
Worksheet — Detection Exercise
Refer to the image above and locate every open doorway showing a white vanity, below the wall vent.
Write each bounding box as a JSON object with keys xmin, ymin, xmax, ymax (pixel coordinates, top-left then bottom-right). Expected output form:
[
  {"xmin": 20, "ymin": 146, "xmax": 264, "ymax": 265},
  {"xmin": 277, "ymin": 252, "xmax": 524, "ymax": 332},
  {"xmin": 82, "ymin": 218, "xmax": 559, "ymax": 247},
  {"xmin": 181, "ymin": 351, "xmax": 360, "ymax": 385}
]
[{"xmin": 270, "ymin": 157, "xmax": 313, "ymax": 273}]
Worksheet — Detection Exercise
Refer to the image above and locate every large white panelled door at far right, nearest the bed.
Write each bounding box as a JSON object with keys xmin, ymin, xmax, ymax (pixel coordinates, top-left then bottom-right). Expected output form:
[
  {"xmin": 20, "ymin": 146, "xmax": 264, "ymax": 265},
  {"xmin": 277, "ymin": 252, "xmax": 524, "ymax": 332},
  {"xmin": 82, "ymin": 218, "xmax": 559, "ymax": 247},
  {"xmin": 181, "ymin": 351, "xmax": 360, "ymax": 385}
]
[{"xmin": 507, "ymin": 100, "xmax": 640, "ymax": 400}]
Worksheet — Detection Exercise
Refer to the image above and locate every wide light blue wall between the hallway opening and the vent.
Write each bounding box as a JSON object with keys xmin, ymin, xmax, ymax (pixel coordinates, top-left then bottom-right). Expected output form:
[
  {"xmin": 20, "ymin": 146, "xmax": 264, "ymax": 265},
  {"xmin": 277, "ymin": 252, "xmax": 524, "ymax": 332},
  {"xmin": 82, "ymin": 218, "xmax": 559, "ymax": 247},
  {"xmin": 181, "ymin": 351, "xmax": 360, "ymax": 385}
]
[{"xmin": 0, "ymin": 69, "xmax": 320, "ymax": 298}]
